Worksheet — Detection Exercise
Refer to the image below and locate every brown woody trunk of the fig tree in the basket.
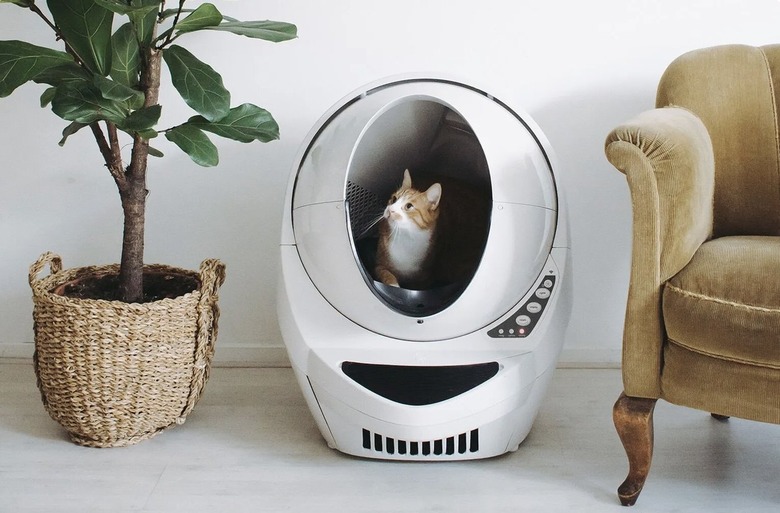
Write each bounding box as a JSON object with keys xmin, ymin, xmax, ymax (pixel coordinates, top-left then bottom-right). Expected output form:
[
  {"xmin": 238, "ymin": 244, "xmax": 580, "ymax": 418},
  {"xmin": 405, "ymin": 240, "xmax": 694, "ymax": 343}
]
[{"xmin": 119, "ymin": 48, "xmax": 162, "ymax": 303}]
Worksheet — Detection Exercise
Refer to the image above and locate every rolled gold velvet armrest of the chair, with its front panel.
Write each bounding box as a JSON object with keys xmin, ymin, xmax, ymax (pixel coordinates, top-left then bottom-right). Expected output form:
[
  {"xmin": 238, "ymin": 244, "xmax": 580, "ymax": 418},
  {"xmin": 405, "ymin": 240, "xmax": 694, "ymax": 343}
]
[{"xmin": 605, "ymin": 107, "xmax": 715, "ymax": 398}]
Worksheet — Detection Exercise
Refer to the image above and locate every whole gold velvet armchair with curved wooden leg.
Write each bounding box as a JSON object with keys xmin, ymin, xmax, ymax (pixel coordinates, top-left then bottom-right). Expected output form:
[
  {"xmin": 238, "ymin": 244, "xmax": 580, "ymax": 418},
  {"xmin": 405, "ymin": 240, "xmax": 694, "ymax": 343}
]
[{"xmin": 605, "ymin": 45, "xmax": 780, "ymax": 505}]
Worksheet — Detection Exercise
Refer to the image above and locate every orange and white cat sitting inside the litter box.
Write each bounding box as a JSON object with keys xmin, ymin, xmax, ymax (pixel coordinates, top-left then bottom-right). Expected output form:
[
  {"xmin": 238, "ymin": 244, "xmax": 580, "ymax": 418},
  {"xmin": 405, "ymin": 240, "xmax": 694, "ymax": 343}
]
[{"xmin": 374, "ymin": 169, "xmax": 490, "ymax": 290}]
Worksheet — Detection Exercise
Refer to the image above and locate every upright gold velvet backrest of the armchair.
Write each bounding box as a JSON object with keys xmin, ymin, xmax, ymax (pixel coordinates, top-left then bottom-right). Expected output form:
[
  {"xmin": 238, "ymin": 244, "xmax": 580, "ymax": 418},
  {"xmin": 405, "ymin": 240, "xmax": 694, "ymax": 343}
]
[{"xmin": 656, "ymin": 45, "xmax": 780, "ymax": 237}]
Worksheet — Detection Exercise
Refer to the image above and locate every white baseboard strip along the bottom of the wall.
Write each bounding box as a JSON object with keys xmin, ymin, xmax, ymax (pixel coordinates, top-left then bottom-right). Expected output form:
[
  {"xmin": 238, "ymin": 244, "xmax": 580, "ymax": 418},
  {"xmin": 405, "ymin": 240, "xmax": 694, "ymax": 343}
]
[{"xmin": 0, "ymin": 343, "xmax": 620, "ymax": 369}]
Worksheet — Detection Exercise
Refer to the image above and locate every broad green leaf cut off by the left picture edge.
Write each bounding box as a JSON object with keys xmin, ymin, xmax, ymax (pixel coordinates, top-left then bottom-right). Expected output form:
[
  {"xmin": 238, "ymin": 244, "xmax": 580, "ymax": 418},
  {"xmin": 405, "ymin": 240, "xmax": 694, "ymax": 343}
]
[{"xmin": 0, "ymin": 41, "xmax": 73, "ymax": 98}]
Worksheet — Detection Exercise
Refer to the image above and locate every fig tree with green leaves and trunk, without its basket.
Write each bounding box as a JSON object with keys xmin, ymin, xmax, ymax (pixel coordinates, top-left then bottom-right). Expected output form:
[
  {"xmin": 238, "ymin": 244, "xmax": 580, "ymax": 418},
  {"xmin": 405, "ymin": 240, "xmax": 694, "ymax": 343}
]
[{"xmin": 0, "ymin": 0, "xmax": 297, "ymax": 302}]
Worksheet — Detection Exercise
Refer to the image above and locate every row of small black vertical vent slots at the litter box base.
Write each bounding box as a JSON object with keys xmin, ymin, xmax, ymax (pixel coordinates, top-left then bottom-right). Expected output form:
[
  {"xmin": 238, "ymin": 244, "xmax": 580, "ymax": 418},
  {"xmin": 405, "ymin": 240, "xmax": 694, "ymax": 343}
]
[{"xmin": 363, "ymin": 429, "xmax": 479, "ymax": 458}]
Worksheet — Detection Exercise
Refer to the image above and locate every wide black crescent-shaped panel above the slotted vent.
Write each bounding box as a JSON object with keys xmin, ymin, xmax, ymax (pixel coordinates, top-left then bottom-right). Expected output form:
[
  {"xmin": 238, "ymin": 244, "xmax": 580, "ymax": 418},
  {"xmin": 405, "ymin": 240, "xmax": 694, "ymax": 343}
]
[{"xmin": 341, "ymin": 362, "xmax": 498, "ymax": 406}]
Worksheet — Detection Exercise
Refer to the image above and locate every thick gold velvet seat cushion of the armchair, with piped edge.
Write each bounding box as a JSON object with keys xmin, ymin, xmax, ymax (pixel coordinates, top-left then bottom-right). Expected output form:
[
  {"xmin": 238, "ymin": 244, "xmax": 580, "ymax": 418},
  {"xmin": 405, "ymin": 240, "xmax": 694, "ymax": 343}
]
[{"xmin": 663, "ymin": 236, "xmax": 780, "ymax": 369}]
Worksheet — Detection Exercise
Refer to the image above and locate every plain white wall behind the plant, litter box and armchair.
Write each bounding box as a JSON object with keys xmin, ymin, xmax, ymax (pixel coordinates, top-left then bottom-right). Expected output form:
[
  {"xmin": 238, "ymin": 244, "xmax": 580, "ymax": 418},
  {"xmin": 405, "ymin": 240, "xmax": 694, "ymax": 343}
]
[{"xmin": 0, "ymin": 0, "xmax": 780, "ymax": 363}]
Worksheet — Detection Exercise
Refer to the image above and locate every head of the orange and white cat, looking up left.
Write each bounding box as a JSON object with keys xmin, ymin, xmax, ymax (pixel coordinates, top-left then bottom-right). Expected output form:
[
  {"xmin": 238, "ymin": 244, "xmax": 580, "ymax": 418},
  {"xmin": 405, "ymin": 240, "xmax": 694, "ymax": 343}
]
[{"xmin": 384, "ymin": 169, "xmax": 442, "ymax": 230}]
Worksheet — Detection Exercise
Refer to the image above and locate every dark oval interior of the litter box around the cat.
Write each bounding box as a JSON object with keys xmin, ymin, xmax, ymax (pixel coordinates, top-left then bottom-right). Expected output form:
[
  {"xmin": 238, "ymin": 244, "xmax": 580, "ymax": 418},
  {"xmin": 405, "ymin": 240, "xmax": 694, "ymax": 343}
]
[{"xmin": 346, "ymin": 98, "xmax": 492, "ymax": 317}]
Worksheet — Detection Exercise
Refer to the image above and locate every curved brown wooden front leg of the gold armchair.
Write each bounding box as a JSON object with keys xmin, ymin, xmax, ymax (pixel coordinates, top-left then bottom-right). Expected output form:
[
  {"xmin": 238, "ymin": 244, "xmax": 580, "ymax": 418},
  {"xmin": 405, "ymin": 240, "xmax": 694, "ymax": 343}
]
[{"xmin": 612, "ymin": 394, "xmax": 656, "ymax": 506}]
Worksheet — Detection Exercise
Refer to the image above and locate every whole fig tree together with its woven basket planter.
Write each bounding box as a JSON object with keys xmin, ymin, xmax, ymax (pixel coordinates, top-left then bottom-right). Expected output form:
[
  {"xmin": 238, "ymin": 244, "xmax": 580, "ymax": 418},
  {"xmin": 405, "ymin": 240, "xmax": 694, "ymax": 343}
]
[{"xmin": 0, "ymin": 0, "xmax": 296, "ymax": 447}]
